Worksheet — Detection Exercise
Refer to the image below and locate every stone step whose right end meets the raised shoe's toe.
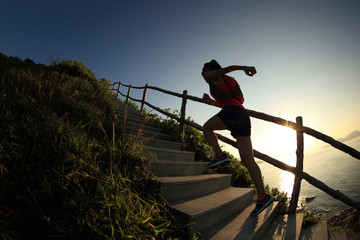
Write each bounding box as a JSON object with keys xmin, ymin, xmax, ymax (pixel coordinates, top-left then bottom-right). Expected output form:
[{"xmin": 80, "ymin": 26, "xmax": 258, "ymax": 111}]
[{"xmin": 150, "ymin": 160, "xmax": 208, "ymax": 177}]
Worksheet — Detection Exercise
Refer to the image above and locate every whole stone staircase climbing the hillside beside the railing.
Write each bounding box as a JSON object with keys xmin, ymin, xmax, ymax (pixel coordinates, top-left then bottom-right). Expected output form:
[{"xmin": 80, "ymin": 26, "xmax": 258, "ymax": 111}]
[{"xmin": 112, "ymin": 98, "xmax": 347, "ymax": 240}]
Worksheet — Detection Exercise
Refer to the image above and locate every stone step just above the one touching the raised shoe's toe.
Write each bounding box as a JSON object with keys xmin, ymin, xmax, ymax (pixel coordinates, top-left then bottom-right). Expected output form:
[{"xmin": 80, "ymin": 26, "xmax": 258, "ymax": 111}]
[{"xmin": 145, "ymin": 146, "xmax": 195, "ymax": 162}]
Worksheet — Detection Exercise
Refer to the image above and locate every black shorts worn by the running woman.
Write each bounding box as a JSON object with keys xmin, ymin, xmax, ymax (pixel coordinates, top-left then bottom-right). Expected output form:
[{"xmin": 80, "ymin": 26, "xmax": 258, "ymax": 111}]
[{"xmin": 217, "ymin": 105, "xmax": 251, "ymax": 138}]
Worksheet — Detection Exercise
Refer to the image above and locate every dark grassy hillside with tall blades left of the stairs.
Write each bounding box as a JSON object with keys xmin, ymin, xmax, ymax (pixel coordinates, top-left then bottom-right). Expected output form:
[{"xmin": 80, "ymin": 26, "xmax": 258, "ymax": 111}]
[{"xmin": 0, "ymin": 54, "xmax": 196, "ymax": 239}]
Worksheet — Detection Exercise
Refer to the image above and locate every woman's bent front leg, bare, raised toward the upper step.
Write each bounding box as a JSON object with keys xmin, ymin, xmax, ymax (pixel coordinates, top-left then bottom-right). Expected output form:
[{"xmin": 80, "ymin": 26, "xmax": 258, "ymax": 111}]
[{"xmin": 203, "ymin": 115, "xmax": 227, "ymax": 155}]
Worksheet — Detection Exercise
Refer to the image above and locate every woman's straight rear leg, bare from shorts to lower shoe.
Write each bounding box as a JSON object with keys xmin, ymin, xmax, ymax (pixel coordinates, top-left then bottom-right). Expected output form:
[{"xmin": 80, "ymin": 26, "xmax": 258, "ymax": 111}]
[{"xmin": 236, "ymin": 136, "xmax": 266, "ymax": 197}]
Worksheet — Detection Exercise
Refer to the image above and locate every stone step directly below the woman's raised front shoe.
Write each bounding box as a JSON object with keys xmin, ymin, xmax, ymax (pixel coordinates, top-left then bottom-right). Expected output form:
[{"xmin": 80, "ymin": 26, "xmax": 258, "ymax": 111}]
[{"xmin": 158, "ymin": 174, "xmax": 231, "ymax": 204}]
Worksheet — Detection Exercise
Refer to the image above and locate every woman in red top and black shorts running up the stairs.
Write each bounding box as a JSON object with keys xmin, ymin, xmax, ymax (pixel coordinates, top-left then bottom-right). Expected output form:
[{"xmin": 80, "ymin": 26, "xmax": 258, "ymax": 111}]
[{"xmin": 201, "ymin": 60, "xmax": 274, "ymax": 216}]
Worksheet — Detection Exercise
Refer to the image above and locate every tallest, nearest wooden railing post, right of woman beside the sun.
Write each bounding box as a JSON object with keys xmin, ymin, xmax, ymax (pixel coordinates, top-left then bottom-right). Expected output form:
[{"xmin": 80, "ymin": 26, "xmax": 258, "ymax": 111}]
[{"xmin": 289, "ymin": 117, "xmax": 304, "ymax": 214}]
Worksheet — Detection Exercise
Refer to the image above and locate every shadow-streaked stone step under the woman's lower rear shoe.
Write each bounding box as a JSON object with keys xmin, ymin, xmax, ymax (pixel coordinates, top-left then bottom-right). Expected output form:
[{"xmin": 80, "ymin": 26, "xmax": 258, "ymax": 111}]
[{"xmin": 201, "ymin": 202, "xmax": 278, "ymax": 240}]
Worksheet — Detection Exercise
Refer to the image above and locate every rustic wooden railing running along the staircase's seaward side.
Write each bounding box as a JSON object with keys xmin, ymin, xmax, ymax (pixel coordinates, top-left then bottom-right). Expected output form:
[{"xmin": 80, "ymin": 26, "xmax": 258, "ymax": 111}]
[{"xmin": 110, "ymin": 82, "xmax": 360, "ymax": 214}]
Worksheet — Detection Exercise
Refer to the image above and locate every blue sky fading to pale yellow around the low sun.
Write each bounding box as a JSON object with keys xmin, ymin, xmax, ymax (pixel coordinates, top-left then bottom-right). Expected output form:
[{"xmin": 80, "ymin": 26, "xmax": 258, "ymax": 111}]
[{"xmin": 0, "ymin": 0, "xmax": 360, "ymax": 159}]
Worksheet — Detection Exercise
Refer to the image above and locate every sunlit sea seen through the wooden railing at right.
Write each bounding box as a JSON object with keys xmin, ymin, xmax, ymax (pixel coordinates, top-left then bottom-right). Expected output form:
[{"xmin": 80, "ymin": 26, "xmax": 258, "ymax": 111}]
[{"xmin": 257, "ymin": 136, "xmax": 360, "ymax": 219}]
